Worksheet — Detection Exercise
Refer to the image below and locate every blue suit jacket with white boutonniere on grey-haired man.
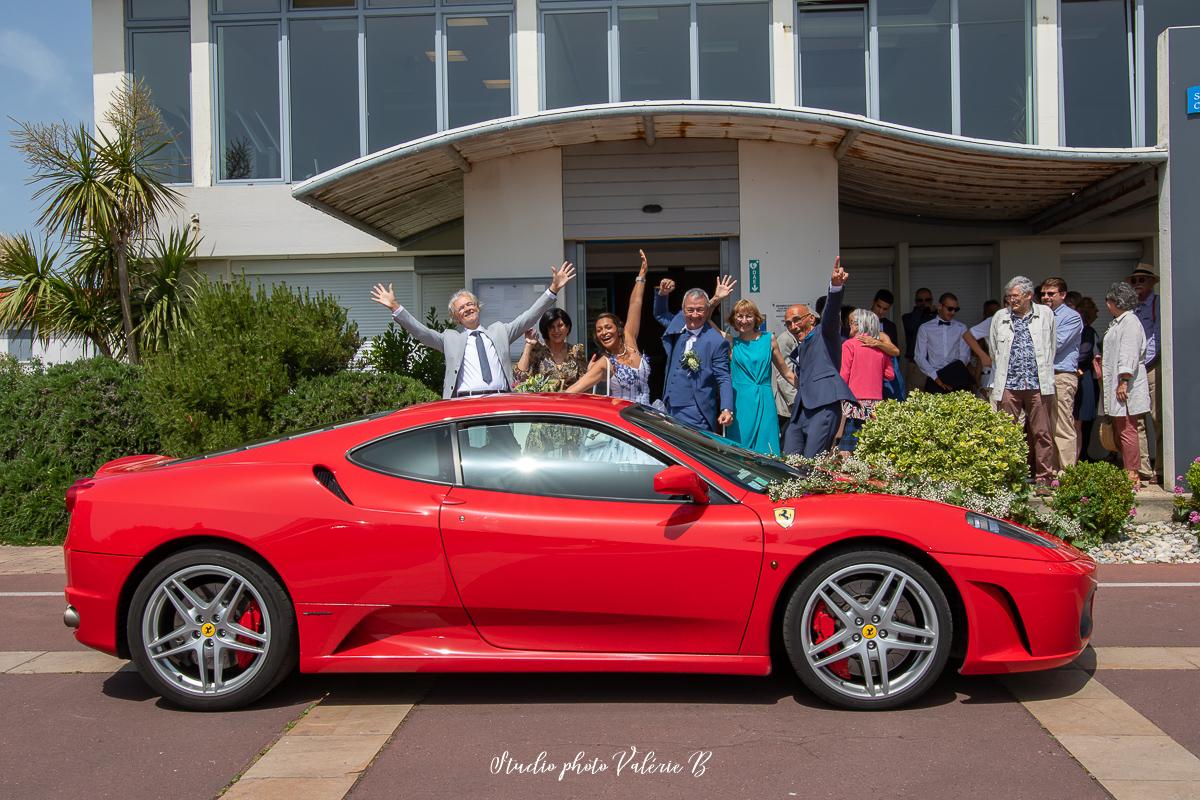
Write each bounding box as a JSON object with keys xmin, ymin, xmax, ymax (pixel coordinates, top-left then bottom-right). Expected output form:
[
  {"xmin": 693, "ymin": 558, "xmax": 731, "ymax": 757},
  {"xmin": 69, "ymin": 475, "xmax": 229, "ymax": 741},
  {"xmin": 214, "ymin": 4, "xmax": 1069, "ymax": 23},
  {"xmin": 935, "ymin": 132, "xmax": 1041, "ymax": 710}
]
[{"xmin": 654, "ymin": 291, "xmax": 733, "ymax": 431}]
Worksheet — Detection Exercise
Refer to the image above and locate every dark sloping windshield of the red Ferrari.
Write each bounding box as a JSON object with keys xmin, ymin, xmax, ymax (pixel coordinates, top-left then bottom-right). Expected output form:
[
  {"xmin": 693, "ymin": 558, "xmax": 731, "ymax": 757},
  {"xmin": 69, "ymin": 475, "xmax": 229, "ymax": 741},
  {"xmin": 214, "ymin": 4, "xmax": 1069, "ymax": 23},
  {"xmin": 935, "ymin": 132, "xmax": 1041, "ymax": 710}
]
[{"xmin": 620, "ymin": 405, "xmax": 804, "ymax": 493}]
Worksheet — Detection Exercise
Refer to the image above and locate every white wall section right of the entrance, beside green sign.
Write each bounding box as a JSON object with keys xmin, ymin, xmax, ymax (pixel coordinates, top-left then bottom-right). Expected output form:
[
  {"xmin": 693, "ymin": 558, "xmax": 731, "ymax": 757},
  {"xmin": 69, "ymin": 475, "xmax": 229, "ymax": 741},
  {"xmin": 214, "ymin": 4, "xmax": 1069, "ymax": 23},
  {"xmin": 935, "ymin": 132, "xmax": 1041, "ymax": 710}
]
[{"xmin": 738, "ymin": 140, "xmax": 853, "ymax": 330}]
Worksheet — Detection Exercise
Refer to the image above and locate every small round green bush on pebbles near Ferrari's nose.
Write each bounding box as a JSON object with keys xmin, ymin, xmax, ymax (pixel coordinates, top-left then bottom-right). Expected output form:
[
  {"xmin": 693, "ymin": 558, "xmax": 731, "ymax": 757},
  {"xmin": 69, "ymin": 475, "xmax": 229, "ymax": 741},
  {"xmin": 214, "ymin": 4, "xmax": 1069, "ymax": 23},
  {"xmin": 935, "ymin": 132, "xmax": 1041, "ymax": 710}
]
[{"xmin": 1050, "ymin": 462, "xmax": 1134, "ymax": 545}]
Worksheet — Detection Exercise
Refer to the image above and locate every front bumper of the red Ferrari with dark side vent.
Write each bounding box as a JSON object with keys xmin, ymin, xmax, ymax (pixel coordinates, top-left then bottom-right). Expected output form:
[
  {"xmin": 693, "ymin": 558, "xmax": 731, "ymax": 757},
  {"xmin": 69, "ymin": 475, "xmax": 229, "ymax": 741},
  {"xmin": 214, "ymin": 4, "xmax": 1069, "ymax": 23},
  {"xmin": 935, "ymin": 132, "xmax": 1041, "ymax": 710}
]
[{"xmin": 940, "ymin": 555, "xmax": 1097, "ymax": 675}]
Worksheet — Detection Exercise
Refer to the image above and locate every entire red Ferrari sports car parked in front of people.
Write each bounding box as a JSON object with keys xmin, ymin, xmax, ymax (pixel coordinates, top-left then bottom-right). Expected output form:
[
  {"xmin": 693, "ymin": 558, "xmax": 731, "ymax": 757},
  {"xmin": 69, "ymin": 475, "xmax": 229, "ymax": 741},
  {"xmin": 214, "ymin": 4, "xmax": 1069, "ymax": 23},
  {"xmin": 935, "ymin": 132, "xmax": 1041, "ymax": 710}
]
[{"xmin": 65, "ymin": 395, "xmax": 1096, "ymax": 710}]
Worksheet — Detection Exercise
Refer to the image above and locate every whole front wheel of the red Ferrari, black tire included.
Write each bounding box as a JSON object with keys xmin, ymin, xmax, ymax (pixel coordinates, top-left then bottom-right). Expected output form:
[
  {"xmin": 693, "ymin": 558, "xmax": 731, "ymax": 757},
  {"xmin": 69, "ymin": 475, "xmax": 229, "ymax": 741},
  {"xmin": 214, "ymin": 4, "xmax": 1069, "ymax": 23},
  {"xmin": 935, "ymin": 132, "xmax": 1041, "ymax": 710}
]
[{"xmin": 784, "ymin": 549, "xmax": 954, "ymax": 710}]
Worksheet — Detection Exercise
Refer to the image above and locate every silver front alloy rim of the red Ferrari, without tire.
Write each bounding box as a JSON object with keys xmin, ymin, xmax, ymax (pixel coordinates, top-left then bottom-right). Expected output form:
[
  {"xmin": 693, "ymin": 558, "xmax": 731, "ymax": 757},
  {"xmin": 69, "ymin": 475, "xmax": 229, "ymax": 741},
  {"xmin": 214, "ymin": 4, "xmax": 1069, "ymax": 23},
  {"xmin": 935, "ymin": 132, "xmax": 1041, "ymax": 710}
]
[{"xmin": 800, "ymin": 564, "xmax": 940, "ymax": 700}]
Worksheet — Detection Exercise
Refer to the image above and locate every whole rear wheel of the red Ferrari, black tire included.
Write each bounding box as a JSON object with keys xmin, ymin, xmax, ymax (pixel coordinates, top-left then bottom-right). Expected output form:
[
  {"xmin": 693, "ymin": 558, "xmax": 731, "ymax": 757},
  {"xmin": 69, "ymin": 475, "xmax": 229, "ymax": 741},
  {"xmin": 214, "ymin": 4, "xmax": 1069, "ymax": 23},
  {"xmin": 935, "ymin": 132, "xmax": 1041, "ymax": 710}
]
[{"xmin": 126, "ymin": 547, "xmax": 296, "ymax": 711}]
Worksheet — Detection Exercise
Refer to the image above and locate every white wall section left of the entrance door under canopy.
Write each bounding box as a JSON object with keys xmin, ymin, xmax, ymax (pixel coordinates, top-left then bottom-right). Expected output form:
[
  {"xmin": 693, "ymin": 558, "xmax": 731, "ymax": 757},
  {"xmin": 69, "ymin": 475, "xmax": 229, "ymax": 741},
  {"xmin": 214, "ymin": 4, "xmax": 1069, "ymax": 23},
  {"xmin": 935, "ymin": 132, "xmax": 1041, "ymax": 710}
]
[{"xmin": 462, "ymin": 148, "xmax": 563, "ymax": 287}]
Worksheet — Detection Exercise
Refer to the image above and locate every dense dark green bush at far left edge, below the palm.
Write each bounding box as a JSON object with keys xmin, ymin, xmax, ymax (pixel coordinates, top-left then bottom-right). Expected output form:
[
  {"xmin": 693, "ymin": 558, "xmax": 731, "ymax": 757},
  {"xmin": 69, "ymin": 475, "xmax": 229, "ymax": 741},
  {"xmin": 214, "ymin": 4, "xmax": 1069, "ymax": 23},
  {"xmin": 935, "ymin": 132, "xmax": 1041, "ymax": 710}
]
[{"xmin": 0, "ymin": 357, "xmax": 158, "ymax": 545}]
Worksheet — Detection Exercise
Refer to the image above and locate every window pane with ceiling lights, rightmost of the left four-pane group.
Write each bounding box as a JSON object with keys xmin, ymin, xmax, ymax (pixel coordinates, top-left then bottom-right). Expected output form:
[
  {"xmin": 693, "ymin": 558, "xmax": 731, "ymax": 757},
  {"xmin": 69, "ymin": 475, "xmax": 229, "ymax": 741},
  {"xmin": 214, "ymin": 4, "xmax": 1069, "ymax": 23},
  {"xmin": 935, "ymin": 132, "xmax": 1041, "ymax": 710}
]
[{"xmin": 445, "ymin": 17, "xmax": 512, "ymax": 128}]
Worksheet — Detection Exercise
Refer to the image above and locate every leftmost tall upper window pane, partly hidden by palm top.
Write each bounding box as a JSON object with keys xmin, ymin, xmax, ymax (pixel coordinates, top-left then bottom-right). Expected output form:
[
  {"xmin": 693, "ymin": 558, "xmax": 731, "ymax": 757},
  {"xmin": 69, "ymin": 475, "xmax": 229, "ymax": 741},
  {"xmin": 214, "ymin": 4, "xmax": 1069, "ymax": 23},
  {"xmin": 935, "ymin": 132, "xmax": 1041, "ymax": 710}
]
[{"xmin": 132, "ymin": 31, "xmax": 192, "ymax": 184}]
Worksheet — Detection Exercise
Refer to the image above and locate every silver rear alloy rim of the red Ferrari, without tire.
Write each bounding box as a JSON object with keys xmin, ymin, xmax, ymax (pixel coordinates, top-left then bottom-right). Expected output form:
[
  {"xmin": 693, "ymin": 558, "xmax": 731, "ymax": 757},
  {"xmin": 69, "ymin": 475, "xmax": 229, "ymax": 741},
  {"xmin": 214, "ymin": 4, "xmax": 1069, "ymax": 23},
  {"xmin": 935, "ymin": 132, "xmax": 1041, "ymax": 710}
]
[{"xmin": 142, "ymin": 564, "xmax": 271, "ymax": 697}]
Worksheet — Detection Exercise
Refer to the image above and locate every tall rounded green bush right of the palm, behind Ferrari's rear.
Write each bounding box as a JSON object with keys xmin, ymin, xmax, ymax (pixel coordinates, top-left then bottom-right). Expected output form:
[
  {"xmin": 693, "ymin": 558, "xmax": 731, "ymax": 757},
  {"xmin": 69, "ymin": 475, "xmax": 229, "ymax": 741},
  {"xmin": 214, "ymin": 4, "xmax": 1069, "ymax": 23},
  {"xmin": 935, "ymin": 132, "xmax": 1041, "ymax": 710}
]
[{"xmin": 145, "ymin": 281, "xmax": 359, "ymax": 456}]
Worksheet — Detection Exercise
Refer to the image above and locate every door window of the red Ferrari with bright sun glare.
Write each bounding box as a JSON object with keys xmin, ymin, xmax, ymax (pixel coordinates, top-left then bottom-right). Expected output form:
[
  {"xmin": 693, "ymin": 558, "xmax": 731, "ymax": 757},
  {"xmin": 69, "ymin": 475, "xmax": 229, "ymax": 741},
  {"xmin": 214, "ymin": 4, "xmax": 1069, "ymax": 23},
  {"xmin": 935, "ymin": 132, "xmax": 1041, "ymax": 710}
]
[{"xmin": 458, "ymin": 421, "xmax": 668, "ymax": 500}]
